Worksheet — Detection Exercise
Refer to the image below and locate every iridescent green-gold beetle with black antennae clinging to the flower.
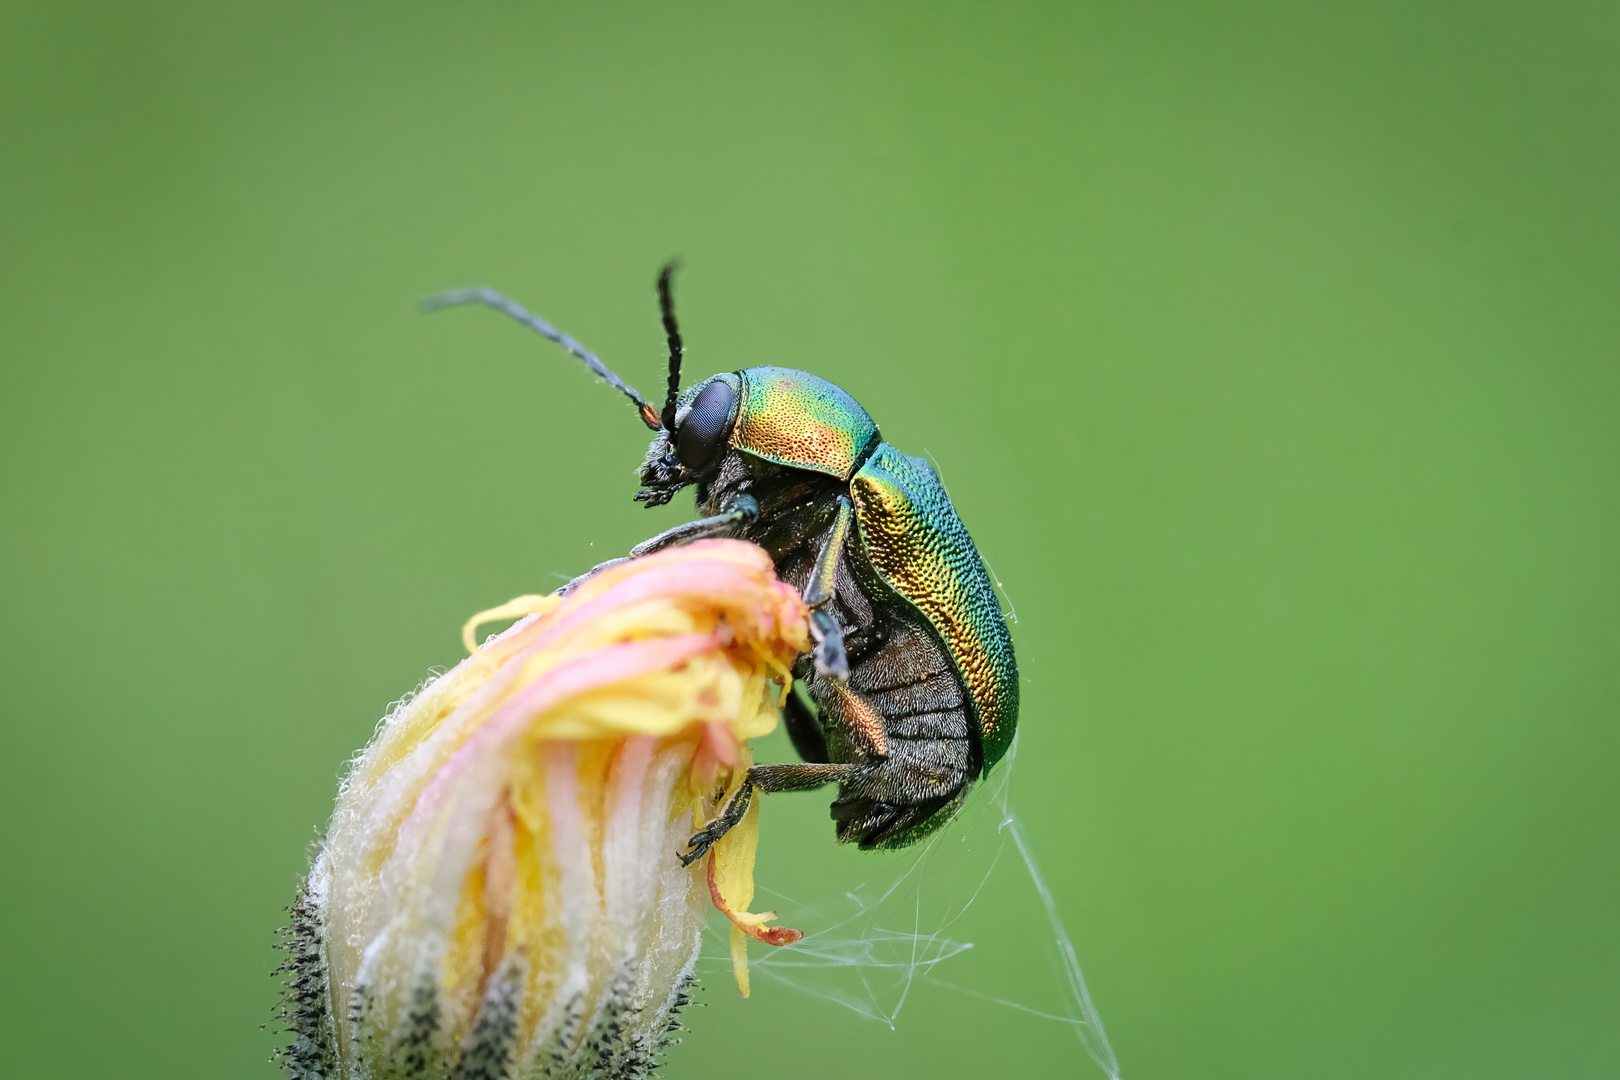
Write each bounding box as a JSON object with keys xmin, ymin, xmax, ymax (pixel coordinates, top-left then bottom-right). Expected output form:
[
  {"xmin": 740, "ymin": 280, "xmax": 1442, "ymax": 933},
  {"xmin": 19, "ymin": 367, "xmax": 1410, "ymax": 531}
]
[{"xmin": 423, "ymin": 272, "xmax": 1019, "ymax": 865}]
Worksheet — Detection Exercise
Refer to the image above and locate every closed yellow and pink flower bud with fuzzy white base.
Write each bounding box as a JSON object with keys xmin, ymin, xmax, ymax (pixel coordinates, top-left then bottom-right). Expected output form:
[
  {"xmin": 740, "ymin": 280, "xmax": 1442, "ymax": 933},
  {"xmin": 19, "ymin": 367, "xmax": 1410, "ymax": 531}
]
[{"xmin": 282, "ymin": 541, "xmax": 808, "ymax": 1080}]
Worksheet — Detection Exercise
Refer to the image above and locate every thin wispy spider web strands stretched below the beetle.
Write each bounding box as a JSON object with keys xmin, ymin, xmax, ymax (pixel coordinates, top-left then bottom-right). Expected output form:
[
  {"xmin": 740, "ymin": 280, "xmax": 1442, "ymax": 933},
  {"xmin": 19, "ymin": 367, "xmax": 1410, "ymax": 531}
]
[{"xmin": 700, "ymin": 742, "xmax": 1119, "ymax": 1080}]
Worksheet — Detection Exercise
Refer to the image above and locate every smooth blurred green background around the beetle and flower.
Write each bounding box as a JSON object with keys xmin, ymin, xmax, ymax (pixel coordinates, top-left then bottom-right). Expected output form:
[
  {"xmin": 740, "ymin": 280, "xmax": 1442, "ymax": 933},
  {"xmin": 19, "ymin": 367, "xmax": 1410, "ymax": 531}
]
[{"xmin": 0, "ymin": 0, "xmax": 1620, "ymax": 1080}]
